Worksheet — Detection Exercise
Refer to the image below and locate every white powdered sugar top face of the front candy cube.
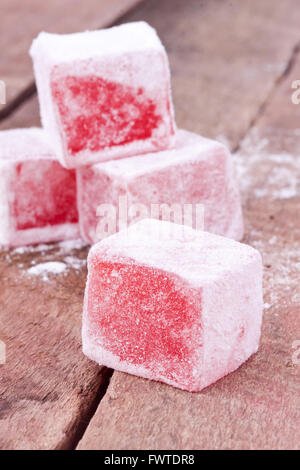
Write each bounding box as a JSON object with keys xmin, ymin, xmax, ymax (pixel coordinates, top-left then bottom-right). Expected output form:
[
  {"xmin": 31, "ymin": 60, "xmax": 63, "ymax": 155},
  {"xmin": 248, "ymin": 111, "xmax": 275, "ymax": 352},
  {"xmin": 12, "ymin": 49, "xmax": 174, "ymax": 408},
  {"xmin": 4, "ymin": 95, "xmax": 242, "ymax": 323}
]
[{"xmin": 89, "ymin": 219, "xmax": 260, "ymax": 287}]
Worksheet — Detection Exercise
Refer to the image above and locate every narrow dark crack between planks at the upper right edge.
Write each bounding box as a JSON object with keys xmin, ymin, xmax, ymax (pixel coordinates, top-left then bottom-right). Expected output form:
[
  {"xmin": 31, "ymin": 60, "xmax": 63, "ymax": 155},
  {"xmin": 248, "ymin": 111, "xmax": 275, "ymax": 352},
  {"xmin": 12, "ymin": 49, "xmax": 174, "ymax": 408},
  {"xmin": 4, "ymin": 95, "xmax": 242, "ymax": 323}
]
[{"xmin": 232, "ymin": 41, "xmax": 300, "ymax": 153}]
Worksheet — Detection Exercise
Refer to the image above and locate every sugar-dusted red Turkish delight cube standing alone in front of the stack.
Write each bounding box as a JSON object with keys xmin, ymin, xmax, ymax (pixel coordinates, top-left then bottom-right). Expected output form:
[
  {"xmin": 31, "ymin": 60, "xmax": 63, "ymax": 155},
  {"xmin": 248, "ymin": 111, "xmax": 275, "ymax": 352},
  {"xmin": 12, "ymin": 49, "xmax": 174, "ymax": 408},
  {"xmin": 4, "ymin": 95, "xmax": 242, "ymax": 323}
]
[{"xmin": 82, "ymin": 219, "xmax": 262, "ymax": 391}]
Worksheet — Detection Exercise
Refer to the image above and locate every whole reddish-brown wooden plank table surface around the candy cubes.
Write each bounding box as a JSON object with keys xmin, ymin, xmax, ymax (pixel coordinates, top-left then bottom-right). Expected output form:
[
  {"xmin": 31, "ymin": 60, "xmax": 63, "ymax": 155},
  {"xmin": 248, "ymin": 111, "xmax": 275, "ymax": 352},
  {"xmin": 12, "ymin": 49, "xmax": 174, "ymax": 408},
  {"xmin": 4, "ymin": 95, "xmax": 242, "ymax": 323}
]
[{"xmin": 0, "ymin": 0, "xmax": 300, "ymax": 450}]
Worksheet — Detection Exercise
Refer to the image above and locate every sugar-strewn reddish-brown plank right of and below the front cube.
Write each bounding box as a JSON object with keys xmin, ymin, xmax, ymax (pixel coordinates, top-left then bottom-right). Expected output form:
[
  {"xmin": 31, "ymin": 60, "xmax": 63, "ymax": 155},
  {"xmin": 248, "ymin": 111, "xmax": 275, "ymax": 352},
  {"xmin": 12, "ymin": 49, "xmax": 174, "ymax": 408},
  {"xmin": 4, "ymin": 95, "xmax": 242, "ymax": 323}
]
[{"xmin": 79, "ymin": 75, "xmax": 300, "ymax": 449}]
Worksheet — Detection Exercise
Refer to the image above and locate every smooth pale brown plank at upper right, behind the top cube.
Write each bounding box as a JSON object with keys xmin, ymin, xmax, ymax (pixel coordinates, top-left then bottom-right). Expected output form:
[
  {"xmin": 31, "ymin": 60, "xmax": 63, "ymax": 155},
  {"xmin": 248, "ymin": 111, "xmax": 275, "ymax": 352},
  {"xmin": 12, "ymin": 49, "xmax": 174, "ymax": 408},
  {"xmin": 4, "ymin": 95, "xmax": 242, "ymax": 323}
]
[{"xmin": 116, "ymin": 0, "xmax": 300, "ymax": 148}]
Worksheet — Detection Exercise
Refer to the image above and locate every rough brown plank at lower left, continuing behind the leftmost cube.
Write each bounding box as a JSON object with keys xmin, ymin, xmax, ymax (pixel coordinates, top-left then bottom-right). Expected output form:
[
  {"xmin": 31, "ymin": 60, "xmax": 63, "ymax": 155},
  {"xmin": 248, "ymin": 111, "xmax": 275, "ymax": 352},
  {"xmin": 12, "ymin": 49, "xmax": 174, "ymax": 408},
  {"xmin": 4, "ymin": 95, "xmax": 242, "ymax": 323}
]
[{"xmin": 0, "ymin": 98, "xmax": 114, "ymax": 449}]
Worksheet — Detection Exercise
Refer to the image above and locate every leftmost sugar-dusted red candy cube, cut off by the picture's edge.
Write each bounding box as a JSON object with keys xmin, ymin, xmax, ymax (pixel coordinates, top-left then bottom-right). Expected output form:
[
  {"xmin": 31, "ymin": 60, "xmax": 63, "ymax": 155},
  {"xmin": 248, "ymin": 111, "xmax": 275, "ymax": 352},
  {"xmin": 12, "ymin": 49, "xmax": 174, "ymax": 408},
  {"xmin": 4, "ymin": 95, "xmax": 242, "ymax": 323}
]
[{"xmin": 0, "ymin": 128, "xmax": 79, "ymax": 246}]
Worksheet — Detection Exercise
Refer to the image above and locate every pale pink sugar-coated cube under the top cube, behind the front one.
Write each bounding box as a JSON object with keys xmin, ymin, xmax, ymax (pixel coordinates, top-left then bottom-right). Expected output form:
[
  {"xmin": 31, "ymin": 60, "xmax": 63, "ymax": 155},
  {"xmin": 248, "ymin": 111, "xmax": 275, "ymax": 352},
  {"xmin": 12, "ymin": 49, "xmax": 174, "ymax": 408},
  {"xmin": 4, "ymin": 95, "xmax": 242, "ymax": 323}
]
[{"xmin": 77, "ymin": 130, "xmax": 243, "ymax": 243}]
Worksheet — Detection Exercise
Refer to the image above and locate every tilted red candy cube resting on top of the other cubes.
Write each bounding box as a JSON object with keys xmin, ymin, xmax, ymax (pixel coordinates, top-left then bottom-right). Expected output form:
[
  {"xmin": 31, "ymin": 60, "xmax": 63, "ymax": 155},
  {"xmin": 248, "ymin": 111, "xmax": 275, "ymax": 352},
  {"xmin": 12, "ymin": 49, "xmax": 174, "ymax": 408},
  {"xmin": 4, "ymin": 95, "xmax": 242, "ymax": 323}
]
[{"xmin": 31, "ymin": 22, "xmax": 175, "ymax": 168}]
